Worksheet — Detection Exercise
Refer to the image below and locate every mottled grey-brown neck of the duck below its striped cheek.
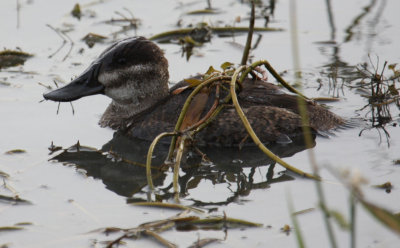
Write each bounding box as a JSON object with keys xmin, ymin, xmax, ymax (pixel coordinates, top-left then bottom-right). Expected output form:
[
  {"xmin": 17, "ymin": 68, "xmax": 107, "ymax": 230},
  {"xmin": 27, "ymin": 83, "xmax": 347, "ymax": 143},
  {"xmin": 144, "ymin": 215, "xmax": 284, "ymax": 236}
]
[{"xmin": 99, "ymin": 64, "xmax": 169, "ymax": 129}]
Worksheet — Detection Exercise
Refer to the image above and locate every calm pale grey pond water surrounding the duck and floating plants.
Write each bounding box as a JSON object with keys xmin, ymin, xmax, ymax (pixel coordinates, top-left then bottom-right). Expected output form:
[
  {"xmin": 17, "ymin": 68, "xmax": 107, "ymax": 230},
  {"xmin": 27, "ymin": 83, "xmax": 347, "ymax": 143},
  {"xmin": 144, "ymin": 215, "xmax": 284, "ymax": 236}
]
[{"xmin": 0, "ymin": 0, "xmax": 400, "ymax": 247}]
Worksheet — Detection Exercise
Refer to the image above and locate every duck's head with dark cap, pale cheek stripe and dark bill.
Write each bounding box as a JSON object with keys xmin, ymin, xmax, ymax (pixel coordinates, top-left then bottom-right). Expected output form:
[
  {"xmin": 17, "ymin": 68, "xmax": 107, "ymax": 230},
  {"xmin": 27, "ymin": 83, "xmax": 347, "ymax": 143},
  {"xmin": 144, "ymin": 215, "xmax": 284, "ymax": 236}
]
[{"xmin": 43, "ymin": 37, "xmax": 168, "ymax": 105}]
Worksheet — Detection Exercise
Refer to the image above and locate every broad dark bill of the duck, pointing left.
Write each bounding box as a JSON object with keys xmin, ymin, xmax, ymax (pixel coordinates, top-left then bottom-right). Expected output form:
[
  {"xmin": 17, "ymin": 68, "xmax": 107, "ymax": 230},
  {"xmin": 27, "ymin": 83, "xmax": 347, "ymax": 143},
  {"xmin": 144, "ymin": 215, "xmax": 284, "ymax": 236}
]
[{"xmin": 43, "ymin": 66, "xmax": 104, "ymax": 102}]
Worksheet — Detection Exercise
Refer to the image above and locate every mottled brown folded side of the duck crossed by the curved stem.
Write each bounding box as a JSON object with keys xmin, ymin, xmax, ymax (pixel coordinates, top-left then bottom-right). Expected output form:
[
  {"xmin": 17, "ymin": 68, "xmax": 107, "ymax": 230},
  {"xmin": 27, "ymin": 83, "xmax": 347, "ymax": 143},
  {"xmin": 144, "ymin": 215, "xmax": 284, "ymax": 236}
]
[{"xmin": 196, "ymin": 106, "xmax": 316, "ymax": 146}]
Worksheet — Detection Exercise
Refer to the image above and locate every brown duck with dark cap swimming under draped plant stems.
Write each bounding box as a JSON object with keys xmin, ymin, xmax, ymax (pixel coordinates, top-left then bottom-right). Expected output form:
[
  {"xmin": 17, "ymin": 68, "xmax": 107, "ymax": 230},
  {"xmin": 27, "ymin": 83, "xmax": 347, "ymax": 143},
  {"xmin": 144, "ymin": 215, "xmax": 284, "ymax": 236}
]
[{"xmin": 43, "ymin": 37, "xmax": 345, "ymax": 147}]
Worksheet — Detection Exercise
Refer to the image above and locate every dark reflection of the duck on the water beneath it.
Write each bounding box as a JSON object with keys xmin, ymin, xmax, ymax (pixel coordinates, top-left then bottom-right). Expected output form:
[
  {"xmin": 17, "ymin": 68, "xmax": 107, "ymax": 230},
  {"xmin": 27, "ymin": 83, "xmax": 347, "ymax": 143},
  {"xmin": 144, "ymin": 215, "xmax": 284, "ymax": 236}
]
[{"xmin": 52, "ymin": 133, "xmax": 315, "ymax": 206}]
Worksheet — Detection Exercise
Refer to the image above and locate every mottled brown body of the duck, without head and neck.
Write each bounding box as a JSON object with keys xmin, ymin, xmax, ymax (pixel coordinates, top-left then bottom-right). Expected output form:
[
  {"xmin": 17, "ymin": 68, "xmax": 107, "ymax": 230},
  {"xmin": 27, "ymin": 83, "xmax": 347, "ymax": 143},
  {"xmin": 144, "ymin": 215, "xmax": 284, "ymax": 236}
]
[{"xmin": 129, "ymin": 79, "xmax": 343, "ymax": 146}]
